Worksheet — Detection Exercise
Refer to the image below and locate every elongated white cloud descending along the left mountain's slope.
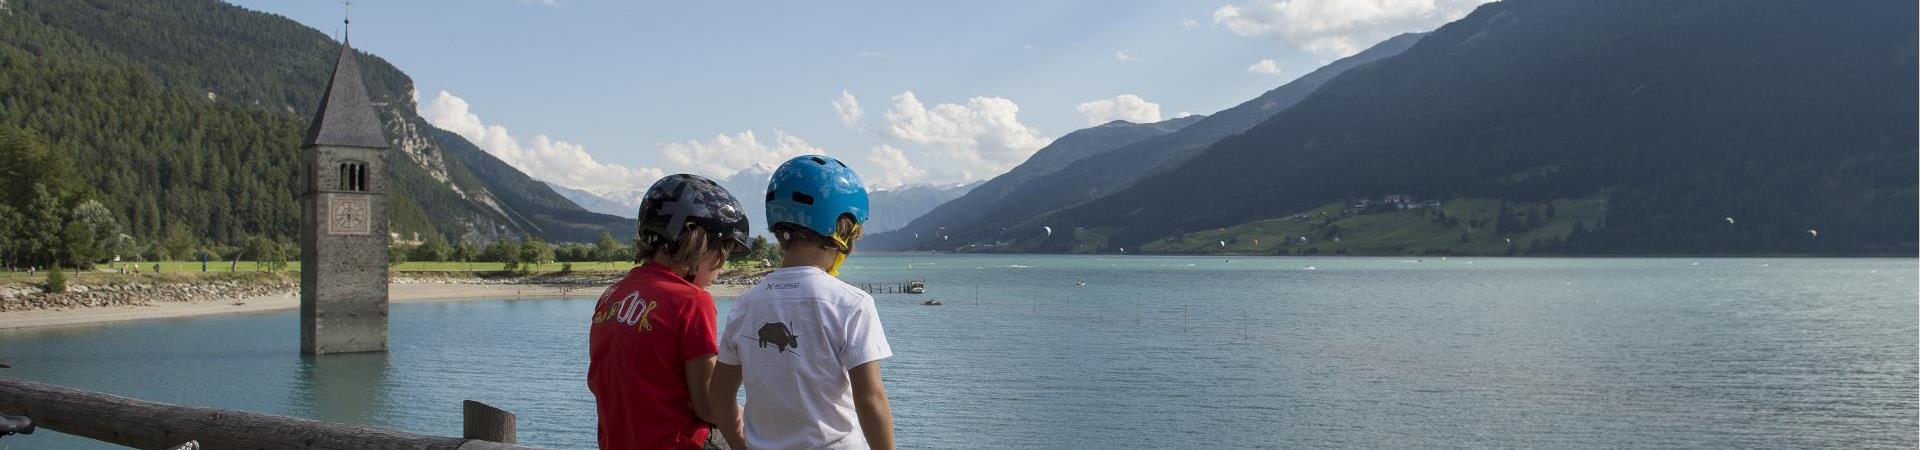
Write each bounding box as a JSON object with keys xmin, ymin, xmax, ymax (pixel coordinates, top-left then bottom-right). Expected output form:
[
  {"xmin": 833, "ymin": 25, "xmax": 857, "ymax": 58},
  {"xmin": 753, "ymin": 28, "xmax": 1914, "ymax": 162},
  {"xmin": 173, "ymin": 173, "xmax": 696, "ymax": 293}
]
[{"xmin": 419, "ymin": 90, "xmax": 664, "ymax": 190}]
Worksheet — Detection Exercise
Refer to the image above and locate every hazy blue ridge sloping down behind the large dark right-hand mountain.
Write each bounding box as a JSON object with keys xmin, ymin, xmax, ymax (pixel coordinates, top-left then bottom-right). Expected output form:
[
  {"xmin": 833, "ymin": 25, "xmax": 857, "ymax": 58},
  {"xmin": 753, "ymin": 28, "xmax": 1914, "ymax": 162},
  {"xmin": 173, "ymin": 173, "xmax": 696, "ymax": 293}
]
[{"xmin": 874, "ymin": 33, "xmax": 1423, "ymax": 250}]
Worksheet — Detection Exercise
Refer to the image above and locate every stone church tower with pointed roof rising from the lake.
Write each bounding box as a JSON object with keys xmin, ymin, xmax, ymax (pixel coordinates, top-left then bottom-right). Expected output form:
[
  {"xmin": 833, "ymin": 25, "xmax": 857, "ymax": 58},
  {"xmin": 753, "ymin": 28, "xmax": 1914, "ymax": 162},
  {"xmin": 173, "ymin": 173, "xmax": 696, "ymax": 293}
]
[{"xmin": 300, "ymin": 42, "xmax": 388, "ymax": 354}]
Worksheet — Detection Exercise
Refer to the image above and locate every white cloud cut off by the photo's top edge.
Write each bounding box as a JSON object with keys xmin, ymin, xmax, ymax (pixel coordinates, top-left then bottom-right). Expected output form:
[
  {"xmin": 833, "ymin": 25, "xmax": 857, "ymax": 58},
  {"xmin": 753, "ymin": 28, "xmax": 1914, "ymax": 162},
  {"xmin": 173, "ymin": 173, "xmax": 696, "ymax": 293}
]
[{"xmin": 1213, "ymin": 0, "xmax": 1490, "ymax": 56}]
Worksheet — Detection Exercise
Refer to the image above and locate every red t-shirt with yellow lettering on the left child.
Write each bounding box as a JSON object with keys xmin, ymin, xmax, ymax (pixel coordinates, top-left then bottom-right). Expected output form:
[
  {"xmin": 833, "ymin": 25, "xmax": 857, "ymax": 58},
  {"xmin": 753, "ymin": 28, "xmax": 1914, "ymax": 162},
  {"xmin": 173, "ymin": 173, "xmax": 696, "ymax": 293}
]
[{"xmin": 588, "ymin": 263, "xmax": 716, "ymax": 448}]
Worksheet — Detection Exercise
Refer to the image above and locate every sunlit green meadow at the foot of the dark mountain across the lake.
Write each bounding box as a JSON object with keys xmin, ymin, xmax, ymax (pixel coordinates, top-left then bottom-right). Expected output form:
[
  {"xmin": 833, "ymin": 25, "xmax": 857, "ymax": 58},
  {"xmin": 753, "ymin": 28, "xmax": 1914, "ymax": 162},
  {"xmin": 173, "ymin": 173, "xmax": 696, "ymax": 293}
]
[{"xmin": 1140, "ymin": 198, "xmax": 1605, "ymax": 256}]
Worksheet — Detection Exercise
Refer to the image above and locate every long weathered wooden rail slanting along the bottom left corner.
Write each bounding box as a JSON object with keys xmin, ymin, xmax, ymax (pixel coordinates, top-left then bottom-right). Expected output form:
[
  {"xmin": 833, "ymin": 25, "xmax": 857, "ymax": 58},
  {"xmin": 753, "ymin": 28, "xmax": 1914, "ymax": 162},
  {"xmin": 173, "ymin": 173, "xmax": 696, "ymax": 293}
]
[{"xmin": 0, "ymin": 377, "xmax": 549, "ymax": 450}]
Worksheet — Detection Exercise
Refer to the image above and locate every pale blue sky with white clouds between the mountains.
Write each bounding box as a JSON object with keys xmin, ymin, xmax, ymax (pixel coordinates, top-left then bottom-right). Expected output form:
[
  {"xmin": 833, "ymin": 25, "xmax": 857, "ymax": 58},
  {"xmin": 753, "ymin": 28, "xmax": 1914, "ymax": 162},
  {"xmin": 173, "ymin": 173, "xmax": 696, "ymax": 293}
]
[{"xmin": 220, "ymin": 0, "xmax": 1482, "ymax": 192}]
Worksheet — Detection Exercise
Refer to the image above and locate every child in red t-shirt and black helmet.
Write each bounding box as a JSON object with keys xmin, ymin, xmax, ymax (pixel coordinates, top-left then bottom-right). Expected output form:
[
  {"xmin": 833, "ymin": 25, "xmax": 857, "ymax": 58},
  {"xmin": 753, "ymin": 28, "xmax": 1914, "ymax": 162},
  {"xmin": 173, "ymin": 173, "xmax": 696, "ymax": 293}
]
[{"xmin": 588, "ymin": 175, "xmax": 749, "ymax": 448}]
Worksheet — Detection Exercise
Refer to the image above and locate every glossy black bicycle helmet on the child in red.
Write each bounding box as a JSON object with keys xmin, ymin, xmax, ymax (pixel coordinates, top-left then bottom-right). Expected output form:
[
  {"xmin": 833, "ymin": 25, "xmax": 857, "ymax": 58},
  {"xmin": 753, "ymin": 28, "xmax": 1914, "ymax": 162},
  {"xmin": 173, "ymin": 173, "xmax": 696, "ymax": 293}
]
[{"xmin": 639, "ymin": 173, "xmax": 753, "ymax": 254}]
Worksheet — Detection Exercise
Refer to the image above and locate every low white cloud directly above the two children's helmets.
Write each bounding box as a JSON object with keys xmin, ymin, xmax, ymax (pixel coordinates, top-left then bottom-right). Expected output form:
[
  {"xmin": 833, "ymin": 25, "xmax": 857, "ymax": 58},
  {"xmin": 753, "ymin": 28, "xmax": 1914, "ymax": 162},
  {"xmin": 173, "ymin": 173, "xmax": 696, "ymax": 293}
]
[{"xmin": 660, "ymin": 129, "xmax": 826, "ymax": 179}]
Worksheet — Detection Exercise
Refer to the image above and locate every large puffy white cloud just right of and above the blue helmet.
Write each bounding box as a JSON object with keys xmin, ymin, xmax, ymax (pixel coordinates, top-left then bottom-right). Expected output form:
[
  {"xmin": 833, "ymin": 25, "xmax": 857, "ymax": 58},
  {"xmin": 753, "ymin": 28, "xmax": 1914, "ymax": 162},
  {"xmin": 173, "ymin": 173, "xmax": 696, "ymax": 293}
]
[{"xmin": 883, "ymin": 90, "xmax": 1052, "ymax": 181}]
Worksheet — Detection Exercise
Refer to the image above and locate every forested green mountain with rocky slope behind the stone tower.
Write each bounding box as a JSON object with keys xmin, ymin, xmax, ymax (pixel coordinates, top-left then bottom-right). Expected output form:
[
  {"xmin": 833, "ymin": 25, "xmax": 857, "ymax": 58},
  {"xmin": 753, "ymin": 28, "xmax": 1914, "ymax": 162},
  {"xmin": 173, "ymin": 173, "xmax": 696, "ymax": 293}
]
[{"xmin": 0, "ymin": 0, "xmax": 632, "ymax": 244}]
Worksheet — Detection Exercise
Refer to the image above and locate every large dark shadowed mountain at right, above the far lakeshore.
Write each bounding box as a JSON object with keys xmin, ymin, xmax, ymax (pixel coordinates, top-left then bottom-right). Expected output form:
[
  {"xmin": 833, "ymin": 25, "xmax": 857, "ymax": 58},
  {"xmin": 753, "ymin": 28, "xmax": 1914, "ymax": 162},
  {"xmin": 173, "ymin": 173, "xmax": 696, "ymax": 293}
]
[{"xmin": 1048, "ymin": 0, "xmax": 1920, "ymax": 254}]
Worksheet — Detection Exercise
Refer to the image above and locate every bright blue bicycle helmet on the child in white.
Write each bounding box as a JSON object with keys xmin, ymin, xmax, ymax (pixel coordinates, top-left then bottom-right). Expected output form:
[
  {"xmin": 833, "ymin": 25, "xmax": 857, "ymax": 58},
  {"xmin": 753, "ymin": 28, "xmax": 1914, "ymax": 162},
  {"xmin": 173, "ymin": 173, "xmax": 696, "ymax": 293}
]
[{"xmin": 766, "ymin": 154, "xmax": 866, "ymax": 237}]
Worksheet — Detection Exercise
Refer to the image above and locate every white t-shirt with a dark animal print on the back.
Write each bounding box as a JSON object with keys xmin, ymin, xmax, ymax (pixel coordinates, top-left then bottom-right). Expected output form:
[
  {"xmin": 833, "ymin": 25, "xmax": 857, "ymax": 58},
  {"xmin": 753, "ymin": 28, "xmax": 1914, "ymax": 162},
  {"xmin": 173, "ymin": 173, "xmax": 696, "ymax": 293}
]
[{"xmin": 718, "ymin": 265, "xmax": 893, "ymax": 450}]
